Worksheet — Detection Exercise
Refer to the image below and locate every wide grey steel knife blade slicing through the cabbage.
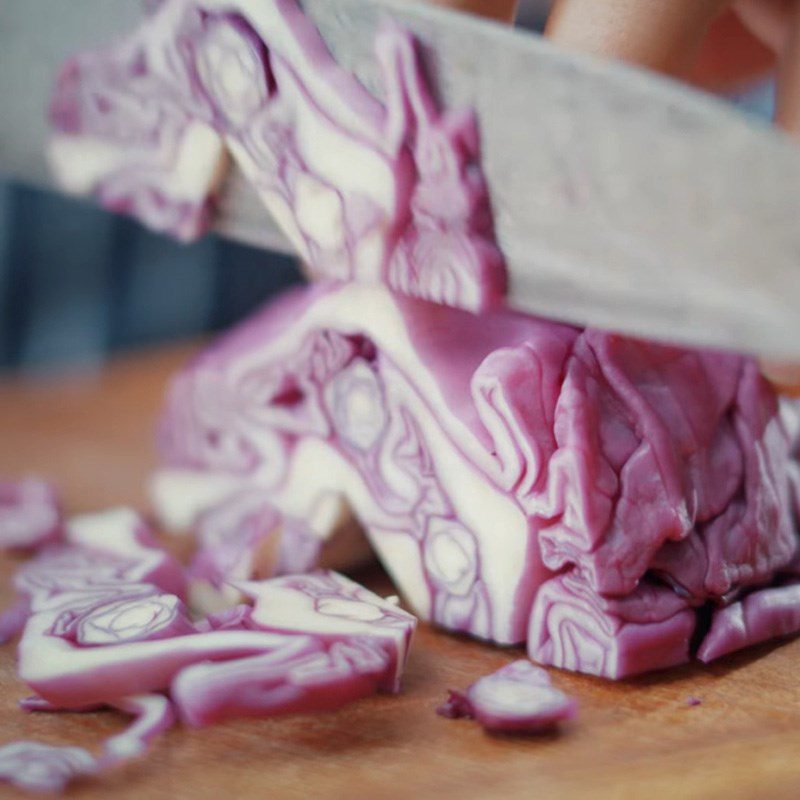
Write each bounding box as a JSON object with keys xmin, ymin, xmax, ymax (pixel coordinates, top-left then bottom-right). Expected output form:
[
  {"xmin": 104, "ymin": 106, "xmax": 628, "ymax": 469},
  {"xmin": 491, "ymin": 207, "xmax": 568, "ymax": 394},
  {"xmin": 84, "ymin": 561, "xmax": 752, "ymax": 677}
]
[{"xmin": 0, "ymin": 0, "xmax": 800, "ymax": 358}]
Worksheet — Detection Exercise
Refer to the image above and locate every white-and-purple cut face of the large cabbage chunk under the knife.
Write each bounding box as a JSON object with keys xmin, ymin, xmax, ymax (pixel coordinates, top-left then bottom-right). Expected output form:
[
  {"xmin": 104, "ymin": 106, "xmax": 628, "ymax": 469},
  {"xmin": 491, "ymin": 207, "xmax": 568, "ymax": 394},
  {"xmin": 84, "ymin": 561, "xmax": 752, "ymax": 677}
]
[{"xmin": 154, "ymin": 285, "xmax": 560, "ymax": 642}]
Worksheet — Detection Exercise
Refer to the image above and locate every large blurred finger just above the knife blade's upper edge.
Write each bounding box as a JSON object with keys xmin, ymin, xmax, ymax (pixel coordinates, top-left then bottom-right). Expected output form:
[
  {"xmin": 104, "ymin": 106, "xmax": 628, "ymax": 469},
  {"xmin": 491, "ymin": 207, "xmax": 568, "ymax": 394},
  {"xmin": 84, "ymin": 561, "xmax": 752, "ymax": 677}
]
[{"xmin": 546, "ymin": 0, "xmax": 730, "ymax": 75}]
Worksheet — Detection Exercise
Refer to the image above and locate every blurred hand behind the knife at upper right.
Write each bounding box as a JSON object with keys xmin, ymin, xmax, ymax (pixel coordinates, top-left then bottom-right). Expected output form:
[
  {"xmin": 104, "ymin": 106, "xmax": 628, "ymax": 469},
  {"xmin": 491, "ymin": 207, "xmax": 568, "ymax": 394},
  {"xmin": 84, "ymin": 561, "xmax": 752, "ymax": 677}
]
[{"xmin": 546, "ymin": 0, "xmax": 800, "ymax": 395}]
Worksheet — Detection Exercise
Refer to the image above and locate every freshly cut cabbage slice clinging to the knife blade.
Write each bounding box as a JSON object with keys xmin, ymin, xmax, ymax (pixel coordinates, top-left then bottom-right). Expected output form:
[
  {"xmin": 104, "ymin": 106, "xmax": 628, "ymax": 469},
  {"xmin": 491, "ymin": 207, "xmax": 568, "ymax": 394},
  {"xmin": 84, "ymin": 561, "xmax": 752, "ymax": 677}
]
[{"xmin": 50, "ymin": 0, "xmax": 506, "ymax": 309}]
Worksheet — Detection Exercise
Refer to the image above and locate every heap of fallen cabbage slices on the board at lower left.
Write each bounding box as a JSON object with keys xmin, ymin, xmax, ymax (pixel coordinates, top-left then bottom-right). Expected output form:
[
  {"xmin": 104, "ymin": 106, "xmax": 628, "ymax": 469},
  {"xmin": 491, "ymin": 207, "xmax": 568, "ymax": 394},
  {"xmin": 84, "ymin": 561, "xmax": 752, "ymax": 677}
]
[{"xmin": 0, "ymin": 509, "xmax": 416, "ymax": 791}]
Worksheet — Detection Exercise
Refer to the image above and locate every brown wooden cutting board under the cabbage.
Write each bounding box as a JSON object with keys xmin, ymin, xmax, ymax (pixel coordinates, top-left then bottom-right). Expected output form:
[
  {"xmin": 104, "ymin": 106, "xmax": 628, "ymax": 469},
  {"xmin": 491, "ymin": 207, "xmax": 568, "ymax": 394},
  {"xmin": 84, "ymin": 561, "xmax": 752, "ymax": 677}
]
[{"xmin": 0, "ymin": 348, "xmax": 800, "ymax": 800}]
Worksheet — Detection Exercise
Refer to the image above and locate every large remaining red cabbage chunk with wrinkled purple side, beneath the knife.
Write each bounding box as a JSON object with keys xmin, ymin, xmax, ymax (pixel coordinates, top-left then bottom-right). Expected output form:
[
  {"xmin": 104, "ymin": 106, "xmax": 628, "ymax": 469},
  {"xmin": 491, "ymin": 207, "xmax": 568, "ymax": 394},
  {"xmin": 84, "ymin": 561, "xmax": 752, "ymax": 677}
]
[{"xmin": 153, "ymin": 284, "xmax": 798, "ymax": 677}]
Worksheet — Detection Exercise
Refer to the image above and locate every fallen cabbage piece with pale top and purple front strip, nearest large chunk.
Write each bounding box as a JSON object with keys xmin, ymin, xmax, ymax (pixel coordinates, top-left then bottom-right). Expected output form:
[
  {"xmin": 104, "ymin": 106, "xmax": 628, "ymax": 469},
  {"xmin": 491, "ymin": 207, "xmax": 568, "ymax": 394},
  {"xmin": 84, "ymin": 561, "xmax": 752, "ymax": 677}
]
[{"xmin": 171, "ymin": 572, "xmax": 415, "ymax": 726}]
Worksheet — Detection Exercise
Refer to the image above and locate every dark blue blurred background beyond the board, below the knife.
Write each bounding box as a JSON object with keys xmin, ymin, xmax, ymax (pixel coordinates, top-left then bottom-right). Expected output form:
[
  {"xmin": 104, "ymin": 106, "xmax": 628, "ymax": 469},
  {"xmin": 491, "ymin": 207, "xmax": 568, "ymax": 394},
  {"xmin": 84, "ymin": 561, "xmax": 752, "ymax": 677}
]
[{"xmin": 0, "ymin": 0, "xmax": 773, "ymax": 375}]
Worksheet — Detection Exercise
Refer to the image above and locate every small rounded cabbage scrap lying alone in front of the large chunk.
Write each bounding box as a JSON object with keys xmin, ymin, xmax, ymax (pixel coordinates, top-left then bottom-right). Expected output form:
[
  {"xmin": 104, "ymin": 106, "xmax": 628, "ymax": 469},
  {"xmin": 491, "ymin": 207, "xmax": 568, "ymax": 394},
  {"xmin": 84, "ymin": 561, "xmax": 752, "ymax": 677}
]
[{"xmin": 436, "ymin": 659, "xmax": 578, "ymax": 733}]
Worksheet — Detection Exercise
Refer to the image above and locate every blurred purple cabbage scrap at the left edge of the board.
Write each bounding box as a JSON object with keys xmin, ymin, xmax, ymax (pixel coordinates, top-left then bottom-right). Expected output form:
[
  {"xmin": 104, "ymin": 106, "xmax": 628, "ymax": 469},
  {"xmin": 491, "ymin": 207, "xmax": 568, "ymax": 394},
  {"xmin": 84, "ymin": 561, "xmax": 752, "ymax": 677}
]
[{"xmin": 0, "ymin": 478, "xmax": 61, "ymax": 550}]
